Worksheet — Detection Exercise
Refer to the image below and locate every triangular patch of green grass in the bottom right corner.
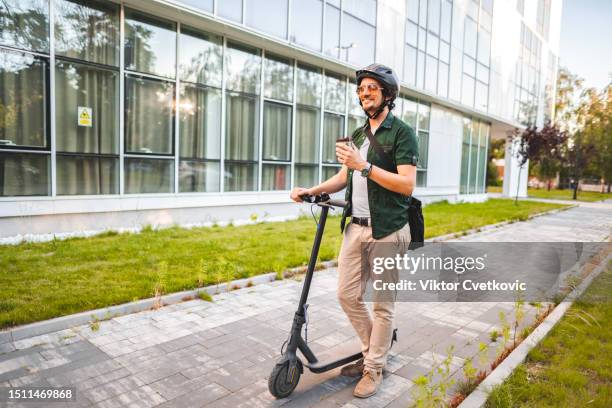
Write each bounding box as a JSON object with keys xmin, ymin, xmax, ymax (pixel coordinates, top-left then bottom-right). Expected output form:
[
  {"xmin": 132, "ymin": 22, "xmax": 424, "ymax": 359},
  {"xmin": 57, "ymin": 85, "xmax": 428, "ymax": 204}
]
[{"xmin": 487, "ymin": 262, "xmax": 612, "ymax": 408}]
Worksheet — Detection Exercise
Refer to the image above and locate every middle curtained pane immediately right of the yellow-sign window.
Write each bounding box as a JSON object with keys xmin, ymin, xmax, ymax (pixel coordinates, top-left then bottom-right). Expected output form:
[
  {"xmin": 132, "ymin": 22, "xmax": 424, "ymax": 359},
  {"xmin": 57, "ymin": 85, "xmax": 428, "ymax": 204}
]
[{"xmin": 125, "ymin": 75, "xmax": 174, "ymax": 155}]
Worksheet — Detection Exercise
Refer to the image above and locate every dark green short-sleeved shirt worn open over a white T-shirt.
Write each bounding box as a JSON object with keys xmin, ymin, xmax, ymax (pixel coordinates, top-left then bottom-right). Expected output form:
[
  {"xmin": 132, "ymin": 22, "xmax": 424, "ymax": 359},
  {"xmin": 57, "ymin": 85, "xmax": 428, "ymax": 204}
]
[{"xmin": 341, "ymin": 112, "xmax": 419, "ymax": 239}]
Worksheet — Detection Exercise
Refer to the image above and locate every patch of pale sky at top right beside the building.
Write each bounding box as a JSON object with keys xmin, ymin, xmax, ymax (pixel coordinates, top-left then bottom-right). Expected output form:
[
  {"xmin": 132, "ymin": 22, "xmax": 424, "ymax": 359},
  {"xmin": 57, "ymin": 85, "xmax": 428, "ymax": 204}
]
[{"xmin": 559, "ymin": 0, "xmax": 612, "ymax": 89}]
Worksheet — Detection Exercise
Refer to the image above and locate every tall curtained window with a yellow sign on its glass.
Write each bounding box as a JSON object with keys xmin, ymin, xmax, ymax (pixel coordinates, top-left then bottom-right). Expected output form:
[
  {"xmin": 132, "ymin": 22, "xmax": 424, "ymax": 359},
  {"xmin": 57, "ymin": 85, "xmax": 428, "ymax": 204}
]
[{"xmin": 55, "ymin": 59, "xmax": 119, "ymax": 195}]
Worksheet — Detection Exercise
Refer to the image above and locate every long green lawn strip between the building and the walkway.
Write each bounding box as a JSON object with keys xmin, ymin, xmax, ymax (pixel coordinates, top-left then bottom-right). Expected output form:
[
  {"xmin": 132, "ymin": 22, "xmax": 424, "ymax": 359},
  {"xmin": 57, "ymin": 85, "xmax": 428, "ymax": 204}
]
[{"xmin": 0, "ymin": 199, "xmax": 563, "ymax": 328}]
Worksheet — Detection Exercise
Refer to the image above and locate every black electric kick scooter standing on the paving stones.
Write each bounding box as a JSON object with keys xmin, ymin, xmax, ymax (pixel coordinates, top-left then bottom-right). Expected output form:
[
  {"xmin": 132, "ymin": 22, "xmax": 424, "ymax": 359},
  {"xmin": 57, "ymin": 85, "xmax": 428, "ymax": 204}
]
[{"xmin": 268, "ymin": 193, "xmax": 397, "ymax": 398}]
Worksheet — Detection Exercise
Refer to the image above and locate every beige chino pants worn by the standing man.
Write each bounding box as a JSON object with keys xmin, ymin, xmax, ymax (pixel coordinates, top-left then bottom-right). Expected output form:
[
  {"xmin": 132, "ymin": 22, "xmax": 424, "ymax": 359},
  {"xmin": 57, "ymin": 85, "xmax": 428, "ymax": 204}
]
[{"xmin": 338, "ymin": 223, "xmax": 410, "ymax": 370}]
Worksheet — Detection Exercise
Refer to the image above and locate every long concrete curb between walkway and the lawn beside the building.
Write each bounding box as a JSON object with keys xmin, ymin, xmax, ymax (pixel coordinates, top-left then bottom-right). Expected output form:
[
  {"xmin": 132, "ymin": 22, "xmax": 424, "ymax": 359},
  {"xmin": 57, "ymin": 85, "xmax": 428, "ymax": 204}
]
[{"xmin": 0, "ymin": 207, "xmax": 572, "ymax": 345}]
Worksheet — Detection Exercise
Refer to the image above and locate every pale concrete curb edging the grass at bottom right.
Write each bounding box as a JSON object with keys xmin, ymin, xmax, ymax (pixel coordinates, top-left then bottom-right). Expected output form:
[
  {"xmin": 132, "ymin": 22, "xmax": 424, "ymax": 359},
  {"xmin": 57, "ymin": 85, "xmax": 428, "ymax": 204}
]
[{"xmin": 458, "ymin": 247, "xmax": 612, "ymax": 408}]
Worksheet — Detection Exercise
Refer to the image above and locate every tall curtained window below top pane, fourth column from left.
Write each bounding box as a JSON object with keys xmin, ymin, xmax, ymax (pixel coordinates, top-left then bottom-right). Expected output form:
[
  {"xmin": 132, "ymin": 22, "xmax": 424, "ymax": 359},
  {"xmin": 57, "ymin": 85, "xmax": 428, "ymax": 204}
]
[{"xmin": 179, "ymin": 84, "xmax": 221, "ymax": 192}]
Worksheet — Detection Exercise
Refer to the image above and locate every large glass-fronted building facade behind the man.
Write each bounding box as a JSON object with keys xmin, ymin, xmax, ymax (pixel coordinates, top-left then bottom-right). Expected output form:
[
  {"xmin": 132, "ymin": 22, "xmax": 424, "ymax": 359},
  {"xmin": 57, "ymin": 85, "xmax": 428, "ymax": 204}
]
[{"xmin": 0, "ymin": 0, "xmax": 560, "ymax": 230}]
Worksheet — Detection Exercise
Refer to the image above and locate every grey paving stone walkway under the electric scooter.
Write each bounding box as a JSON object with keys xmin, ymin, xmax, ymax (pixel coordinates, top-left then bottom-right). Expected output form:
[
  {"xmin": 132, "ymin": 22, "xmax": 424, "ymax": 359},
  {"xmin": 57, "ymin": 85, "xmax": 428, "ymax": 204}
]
[{"xmin": 0, "ymin": 203, "xmax": 612, "ymax": 408}]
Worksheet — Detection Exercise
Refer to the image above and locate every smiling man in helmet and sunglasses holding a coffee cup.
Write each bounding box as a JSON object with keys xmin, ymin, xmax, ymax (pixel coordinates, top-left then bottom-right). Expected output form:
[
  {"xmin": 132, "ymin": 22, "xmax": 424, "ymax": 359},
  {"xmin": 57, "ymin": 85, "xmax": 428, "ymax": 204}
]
[{"xmin": 291, "ymin": 64, "xmax": 418, "ymax": 398}]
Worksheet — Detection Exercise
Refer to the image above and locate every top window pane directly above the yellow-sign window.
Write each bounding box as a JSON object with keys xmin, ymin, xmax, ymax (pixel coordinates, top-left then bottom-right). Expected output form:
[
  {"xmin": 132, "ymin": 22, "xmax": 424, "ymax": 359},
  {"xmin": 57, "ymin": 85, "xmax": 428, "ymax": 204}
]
[{"xmin": 55, "ymin": 0, "xmax": 119, "ymax": 66}]
